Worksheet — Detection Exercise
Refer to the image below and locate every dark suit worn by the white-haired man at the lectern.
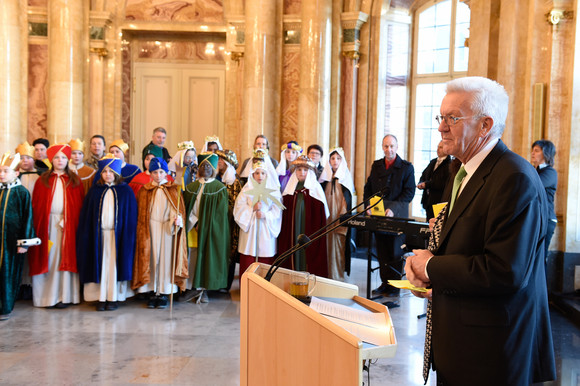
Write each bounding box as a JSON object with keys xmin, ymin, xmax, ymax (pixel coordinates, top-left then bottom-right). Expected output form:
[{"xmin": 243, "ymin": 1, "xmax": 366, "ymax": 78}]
[{"xmin": 427, "ymin": 141, "xmax": 555, "ymax": 385}]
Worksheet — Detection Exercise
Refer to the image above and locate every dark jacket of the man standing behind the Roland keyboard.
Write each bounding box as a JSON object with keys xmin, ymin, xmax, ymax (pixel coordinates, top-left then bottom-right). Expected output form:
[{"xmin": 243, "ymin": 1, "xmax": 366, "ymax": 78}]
[{"xmin": 364, "ymin": 154, "xmax": 415, "ymax": 217}]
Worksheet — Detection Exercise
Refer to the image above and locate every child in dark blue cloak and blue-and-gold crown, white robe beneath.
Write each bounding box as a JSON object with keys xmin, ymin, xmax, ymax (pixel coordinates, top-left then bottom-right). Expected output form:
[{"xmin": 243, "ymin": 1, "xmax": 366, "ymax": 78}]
[{"xmin": 77, "ymin": 154, "xmax": 137, "ymax": 311}]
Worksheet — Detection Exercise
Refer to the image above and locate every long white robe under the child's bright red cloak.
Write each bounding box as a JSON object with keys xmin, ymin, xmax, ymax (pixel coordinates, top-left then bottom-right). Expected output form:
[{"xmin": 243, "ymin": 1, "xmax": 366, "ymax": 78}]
[{"xmin": 32, "ymin": 178, "xmax": 80, "ymax": 307}]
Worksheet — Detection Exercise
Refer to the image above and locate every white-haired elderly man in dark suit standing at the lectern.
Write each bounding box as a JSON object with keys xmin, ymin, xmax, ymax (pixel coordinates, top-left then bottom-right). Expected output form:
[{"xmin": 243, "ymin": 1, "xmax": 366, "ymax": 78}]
[{"xmin": 406, "ymin": 77, "xmax": 555, "ymax": 385}]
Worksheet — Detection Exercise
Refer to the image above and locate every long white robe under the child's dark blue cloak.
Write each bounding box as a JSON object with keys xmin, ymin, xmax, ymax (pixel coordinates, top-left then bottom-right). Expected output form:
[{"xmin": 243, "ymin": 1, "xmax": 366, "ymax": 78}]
[{"xmin": 84, "ymin": 189, "xmax": 133, "ymax": 302}]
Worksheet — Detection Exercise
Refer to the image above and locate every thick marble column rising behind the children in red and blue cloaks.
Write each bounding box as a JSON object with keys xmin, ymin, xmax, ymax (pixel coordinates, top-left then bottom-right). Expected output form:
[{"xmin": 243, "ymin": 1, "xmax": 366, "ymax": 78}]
[{"xmin": 47, "ymin": 0, "xmax": 88, "ymax": 144}]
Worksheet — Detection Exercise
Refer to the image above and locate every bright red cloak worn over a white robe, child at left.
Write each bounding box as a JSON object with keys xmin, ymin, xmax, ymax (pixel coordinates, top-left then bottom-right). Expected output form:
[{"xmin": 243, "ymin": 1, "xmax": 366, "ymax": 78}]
[{"xmin": 28, "ymin": 173, "xmax": 84, "ymax": 276}]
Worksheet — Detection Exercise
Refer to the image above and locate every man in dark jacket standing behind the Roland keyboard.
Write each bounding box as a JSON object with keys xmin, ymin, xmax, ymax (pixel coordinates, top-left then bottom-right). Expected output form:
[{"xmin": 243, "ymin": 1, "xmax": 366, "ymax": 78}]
[{"xmin": 364, "ymin": 134, "xmax": 415, "ymax": 295}]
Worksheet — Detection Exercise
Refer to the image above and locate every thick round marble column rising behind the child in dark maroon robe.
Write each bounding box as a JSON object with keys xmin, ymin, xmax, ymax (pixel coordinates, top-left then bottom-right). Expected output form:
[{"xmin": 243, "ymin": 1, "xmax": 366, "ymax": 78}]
[{"xmin": 297, "ymin": 0, "xmax": 332, "ymax": 149}]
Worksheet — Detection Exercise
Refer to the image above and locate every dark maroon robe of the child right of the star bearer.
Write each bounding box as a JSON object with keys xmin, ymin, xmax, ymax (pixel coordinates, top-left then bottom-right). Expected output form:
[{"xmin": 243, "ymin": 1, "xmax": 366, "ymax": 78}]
[{"xmin": 278, "ymin": 189, "xmax": 328, "ymax": 277}]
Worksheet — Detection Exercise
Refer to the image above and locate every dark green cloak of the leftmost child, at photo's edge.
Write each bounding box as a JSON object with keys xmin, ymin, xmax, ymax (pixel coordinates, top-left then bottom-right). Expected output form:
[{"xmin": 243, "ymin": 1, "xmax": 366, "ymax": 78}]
[{"xmin": 0, "ymin": 180, "xmax": 36, "ymax": 315}]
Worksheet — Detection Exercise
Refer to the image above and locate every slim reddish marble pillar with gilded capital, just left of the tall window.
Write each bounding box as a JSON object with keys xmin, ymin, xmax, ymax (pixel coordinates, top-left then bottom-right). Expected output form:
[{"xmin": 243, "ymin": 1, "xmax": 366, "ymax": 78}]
[{"xmin": 340, "ymin": 12, "xmax": 369, "ymax": 175}]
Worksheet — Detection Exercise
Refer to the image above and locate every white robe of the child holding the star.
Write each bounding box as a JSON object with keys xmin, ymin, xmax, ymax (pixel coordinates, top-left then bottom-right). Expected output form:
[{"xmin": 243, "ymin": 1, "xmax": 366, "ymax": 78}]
[{"xmin": 234, "ymin": 175, "xmax": 282, "ymax": 257}]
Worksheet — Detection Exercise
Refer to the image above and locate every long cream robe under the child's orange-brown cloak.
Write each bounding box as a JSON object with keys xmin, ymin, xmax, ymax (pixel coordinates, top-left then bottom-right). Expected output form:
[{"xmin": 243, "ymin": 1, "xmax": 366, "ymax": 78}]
[{"xmin": 137, "ymin": 185, "xmax": 177, "ymax": 295}]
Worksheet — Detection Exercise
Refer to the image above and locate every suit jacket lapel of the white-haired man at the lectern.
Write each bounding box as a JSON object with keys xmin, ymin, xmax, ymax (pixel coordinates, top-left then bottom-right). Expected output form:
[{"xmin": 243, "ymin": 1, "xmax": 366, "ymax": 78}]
[{"xmin": 439, "ymin": 139, "xmax": 507, "ymax": 249}]
